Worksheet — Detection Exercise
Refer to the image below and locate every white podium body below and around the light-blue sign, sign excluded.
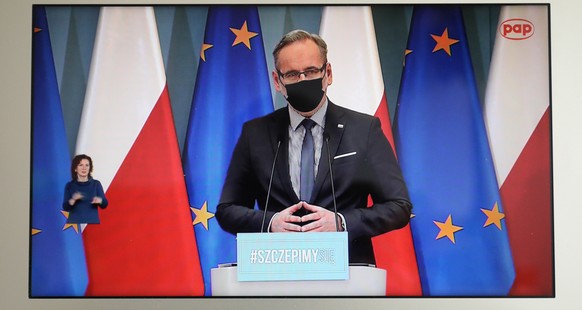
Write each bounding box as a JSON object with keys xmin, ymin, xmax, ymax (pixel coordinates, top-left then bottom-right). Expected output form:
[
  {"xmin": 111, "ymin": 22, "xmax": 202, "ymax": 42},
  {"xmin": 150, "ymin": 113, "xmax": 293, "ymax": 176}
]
[{"xmin": 210, "ymin": 266, "xmax": 386, "ymax": 296}]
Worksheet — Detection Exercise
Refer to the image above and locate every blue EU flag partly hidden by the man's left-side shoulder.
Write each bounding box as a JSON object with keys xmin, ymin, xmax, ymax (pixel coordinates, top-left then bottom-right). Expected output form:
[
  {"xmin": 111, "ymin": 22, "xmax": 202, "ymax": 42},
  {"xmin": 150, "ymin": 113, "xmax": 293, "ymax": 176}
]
[{"xmin": 183, "ymin": 6, "xmax": 273, "ymax": 295}]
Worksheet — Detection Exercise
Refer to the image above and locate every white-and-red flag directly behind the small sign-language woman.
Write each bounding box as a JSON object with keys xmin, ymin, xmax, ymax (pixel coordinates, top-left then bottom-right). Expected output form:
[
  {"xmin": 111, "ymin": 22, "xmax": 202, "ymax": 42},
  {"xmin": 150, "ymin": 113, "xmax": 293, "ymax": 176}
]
[{"xmin": 77, "ymin": 7, "xmax": 204, "ymax": 296}]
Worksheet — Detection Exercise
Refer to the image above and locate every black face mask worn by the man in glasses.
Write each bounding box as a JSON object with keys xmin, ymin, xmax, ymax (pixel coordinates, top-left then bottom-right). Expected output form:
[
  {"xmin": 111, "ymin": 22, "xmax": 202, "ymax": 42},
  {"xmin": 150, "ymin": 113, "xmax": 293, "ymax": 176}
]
[{"xmin": 285, "ymin": 77, "xmax": 325, "ymax": 113}]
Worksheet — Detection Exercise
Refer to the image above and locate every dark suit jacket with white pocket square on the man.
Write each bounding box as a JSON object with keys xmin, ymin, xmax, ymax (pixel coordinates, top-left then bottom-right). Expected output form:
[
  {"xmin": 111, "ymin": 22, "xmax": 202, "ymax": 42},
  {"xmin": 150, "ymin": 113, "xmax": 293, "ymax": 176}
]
[{"xmin": 216, "ymin": 102, "xmax": 412, "ymax": 263}]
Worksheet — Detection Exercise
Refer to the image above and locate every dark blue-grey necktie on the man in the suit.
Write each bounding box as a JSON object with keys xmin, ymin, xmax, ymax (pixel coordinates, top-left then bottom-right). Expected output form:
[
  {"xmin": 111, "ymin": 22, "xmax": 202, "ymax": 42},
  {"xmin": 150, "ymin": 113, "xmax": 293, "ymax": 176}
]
[{"xmin": 299, "ymin": 118, "xmax": 315, "ymax": 202}]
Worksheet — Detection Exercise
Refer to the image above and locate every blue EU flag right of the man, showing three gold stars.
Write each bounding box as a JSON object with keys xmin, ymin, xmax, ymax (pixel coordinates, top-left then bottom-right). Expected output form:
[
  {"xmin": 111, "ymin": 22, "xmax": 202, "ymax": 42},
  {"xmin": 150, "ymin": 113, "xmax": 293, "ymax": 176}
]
[{"xmin": 395, "ymin": 6, "xmax": 515, "ymax": 296}]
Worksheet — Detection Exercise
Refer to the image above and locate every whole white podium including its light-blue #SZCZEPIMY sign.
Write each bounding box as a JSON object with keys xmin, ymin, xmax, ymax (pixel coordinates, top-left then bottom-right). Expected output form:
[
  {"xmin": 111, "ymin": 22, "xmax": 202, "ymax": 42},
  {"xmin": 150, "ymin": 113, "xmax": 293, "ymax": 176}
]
[{"xmin": 210, "ymin": 232, "xmax": 386, "ymax": 296}]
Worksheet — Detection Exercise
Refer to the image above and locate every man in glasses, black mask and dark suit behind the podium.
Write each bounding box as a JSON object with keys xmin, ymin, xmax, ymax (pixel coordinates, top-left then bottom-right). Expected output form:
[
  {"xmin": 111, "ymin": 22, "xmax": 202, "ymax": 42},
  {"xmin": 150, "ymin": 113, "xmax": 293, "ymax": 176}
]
[{"xmin": 216, "ymin": 30, "xmax": 412, "ymax": 264}]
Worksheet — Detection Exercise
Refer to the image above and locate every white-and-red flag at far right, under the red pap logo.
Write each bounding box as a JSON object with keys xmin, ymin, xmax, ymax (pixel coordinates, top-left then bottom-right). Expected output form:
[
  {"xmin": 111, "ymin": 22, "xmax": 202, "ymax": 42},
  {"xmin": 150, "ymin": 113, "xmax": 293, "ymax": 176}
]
[{"xmin": 484, "ymin": 5, "xmax": 554, "ymax": 296}]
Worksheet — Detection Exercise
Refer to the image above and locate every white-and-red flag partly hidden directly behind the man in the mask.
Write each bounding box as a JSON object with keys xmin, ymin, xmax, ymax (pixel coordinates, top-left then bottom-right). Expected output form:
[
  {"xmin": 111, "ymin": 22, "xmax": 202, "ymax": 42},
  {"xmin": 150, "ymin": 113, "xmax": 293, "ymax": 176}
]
[{"xmin": 320, "ymin": 6, "xmax": 422, "ymax": 296}]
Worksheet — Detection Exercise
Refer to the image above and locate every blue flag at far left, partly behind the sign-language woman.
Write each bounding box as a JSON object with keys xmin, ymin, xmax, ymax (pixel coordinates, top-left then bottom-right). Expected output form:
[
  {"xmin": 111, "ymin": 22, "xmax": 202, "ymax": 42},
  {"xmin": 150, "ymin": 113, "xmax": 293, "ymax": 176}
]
[{"xmin": 30, "ymin": 5, "xmax": 88, "ymax": 297}]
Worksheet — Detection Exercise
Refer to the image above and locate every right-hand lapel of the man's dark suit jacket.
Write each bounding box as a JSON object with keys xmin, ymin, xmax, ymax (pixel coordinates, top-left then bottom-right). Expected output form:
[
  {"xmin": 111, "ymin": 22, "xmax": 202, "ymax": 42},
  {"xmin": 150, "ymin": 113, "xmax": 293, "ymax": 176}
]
[{"xmin": 311, "ymin": 102, "xmax": 345, "ymax": 201}]
